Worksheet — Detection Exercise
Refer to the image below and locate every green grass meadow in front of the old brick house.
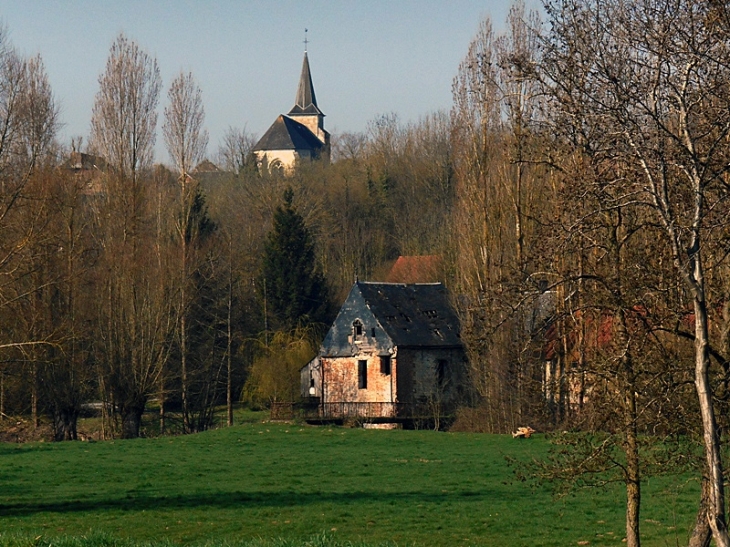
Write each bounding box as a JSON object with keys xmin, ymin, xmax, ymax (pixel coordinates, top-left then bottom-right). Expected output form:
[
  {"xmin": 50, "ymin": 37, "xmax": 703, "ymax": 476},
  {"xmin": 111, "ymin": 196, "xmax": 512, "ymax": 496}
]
[{"xmin": 0, "ymin": 422, "xmax": 698, "ymax": 546}]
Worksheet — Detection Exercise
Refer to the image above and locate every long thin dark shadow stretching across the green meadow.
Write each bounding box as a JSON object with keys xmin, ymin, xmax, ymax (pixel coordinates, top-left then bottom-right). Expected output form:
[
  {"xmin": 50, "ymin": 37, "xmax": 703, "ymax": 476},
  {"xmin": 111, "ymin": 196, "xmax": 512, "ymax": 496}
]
[{"xmin": 0, "ymin": 491, "xmax": 492, "ymax": 517}]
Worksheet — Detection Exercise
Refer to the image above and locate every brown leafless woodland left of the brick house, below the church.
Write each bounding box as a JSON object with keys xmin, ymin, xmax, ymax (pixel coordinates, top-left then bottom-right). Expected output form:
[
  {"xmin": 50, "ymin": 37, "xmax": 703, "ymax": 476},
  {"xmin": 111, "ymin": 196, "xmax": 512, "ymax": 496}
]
[{"xmin": 0, "ymin": 27, "xmax": 453, "ymax": 440}]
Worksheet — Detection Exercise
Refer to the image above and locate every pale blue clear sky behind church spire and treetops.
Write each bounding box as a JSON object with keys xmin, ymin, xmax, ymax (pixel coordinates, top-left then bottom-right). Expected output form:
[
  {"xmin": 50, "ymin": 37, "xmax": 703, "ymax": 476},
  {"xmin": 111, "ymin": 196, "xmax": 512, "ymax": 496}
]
[{"xmin": 0, "ymin": 0, "xmax": 534, "ymax": 162}]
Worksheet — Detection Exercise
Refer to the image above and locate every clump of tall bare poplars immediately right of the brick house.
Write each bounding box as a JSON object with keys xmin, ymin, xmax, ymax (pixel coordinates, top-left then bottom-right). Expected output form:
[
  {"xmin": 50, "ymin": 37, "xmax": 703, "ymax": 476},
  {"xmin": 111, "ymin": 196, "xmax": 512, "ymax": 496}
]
[{"xmin": 451, "ymin": 3, "xmax": 551, "ymax": 431}]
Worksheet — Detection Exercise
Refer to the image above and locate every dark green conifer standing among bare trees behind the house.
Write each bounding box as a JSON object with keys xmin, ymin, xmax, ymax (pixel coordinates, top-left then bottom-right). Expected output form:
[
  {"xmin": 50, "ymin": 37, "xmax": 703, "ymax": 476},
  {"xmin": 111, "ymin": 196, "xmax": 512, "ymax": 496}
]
[{"xmin": 263, "ymin": 188, "xmax": 329, "ymax": 329}]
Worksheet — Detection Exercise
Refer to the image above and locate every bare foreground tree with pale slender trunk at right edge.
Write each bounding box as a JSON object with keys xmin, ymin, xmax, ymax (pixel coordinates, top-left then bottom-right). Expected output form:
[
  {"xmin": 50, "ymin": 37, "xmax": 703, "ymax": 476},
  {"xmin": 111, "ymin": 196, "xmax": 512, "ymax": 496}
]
[{"xmin": 544, "ymin": 0, "xmax": 730, "ymax": 546}]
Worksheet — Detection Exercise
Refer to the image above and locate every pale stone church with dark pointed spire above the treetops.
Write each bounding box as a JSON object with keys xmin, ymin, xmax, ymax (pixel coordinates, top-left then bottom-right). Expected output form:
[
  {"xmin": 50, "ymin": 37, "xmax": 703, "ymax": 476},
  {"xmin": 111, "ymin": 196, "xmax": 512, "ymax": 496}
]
[{"xmin": 253, "ymin": 51, "xmax": 330, "ymax": 171}]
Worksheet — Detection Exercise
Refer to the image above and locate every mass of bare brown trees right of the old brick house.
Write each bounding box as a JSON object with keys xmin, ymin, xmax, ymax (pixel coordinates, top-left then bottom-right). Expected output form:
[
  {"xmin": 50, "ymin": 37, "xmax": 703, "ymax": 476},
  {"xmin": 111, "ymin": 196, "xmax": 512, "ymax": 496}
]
[{"xmin": 451, "ymin": 0, "xmax": 730, "ymax": 546}]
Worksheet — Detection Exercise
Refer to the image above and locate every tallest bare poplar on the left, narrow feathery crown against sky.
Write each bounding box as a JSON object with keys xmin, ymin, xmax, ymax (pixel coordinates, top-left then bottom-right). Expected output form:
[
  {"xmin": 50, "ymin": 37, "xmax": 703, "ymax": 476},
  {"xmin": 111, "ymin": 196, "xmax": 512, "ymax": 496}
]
[{"xmin": 91, "ymin": 35, "xmax": 166, "ymax": 437}]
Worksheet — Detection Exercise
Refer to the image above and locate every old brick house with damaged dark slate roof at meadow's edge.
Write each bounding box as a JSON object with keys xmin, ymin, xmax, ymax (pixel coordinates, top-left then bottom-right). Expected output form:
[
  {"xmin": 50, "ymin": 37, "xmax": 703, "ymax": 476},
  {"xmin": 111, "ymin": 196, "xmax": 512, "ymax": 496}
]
[{"xmin": 301, "ymin": 282, "xmax": 466, "ymax": 422}]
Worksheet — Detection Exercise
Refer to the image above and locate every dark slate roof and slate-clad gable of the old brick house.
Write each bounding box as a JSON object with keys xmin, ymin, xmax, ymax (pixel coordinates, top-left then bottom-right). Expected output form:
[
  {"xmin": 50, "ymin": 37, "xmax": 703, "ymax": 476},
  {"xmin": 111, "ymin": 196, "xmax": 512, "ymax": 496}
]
[{"xmin": 321, "ymin": 281, "xmax": 462, "ymax": 357}]
